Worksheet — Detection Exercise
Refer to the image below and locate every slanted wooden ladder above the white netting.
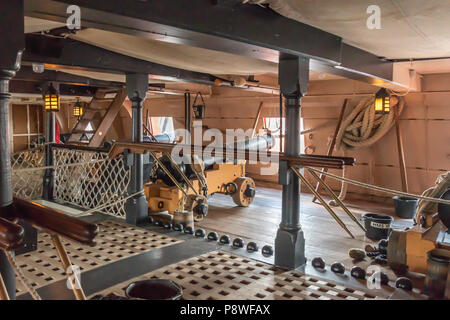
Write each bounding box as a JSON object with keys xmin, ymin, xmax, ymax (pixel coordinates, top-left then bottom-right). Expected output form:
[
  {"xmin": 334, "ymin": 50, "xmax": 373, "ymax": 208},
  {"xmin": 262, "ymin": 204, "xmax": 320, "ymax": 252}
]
[{"xmin": 68, "ymin": 89, "xmax": 127, "ymax": 148}]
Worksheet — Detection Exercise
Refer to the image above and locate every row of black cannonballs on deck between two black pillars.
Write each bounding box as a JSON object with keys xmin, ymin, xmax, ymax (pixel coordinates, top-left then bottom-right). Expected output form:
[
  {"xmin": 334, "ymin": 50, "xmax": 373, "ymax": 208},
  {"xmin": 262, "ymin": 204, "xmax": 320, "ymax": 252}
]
[{"xmin": 150, "ymin": 218, "xmax": 273, "ymax": 257}]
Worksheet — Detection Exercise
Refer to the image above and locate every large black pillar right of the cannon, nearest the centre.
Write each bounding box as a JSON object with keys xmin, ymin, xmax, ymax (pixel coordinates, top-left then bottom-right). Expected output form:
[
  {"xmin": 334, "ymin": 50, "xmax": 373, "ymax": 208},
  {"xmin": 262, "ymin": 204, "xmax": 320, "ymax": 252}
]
[{"xmin": 275, "ymin": 55, "xmax": 309, "ymax": 269}]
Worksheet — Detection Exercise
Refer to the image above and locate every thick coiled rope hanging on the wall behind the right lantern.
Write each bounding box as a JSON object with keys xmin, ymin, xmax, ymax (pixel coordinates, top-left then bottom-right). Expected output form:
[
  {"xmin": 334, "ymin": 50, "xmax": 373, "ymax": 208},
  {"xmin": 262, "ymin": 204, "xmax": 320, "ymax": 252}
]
[{"xmin": 330, "ymin": 97, "xmax": 405, "ymax": 206}]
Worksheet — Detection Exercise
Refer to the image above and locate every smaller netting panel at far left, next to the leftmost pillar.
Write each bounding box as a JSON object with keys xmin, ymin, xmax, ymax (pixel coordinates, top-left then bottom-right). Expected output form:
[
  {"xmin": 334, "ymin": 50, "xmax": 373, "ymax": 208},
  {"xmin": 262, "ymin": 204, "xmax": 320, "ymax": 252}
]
[{"xmin": 11, "ymin": 145, "xmax": 45, "ymax": 200}]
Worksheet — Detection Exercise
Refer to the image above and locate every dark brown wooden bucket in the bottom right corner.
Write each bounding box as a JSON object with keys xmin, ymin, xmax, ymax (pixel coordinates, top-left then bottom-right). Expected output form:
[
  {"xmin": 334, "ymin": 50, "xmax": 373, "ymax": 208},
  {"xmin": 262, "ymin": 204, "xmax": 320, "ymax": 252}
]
[{"xmin": 424, "ymin": 249, "xmax": 450, "ymax": 299}]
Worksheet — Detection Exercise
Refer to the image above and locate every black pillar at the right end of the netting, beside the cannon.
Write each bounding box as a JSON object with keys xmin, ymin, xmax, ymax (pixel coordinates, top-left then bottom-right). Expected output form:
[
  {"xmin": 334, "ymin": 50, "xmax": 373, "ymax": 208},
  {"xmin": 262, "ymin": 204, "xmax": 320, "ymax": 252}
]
[{"xmin": 125, "ymin": 74, "xmax": 148, "ymax": 225}]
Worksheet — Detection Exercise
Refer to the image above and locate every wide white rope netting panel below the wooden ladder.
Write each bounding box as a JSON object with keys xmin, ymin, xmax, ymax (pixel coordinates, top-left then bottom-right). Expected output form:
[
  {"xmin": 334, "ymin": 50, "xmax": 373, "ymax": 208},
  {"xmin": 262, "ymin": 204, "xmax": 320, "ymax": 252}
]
[{"xmin": 53, "ymin": 148, "xmax": 131, "ymax": 218}]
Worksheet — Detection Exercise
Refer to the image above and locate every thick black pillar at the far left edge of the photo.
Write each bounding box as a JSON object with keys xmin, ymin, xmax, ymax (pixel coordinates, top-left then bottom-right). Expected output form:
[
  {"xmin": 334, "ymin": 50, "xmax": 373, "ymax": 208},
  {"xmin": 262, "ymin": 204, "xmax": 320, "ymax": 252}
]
[{"xmin": 0, "ymin": 0, "xmax": 25, "ymax": 299}]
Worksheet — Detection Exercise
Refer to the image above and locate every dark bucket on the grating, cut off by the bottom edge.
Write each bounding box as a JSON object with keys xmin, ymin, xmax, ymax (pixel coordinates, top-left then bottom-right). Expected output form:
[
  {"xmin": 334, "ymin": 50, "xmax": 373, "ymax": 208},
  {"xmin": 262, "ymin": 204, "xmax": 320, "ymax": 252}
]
[{"xmin": 125, "ymin": 279, "xmax": 183, "ymax": 300}]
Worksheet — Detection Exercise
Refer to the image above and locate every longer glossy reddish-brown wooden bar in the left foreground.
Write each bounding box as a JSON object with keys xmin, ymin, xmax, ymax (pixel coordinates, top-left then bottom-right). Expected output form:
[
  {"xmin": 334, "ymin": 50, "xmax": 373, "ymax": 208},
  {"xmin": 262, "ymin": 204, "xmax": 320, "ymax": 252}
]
[{"xmin": 9, "ymin": 197, "xmax": 99, "ymax": 246}]
